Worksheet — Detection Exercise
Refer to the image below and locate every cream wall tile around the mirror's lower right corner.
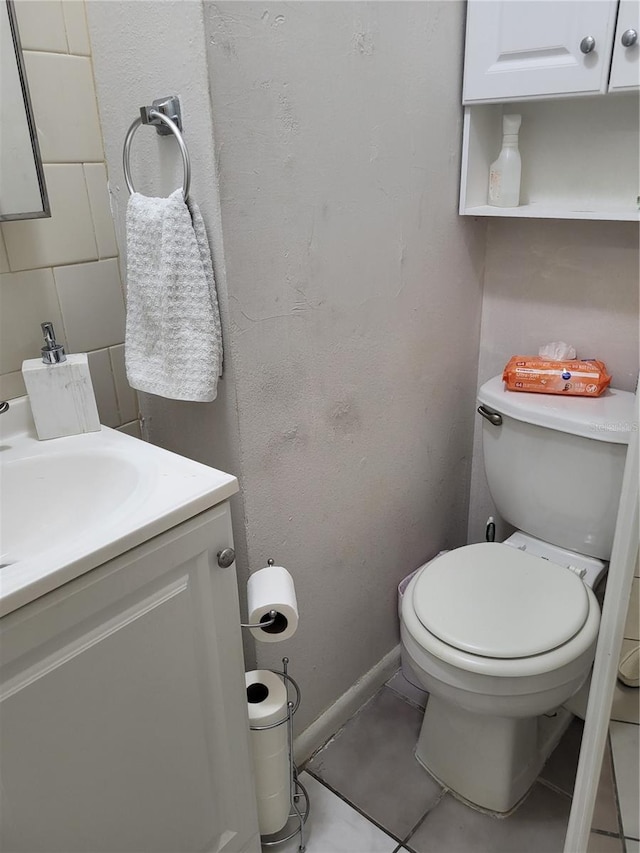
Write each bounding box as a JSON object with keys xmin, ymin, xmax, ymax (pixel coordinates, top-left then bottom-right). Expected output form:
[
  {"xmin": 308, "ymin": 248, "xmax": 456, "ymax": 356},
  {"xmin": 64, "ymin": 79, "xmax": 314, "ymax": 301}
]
[{"xmin": 2, "ymin": 163, "xmax": 98, "ymax": 271}]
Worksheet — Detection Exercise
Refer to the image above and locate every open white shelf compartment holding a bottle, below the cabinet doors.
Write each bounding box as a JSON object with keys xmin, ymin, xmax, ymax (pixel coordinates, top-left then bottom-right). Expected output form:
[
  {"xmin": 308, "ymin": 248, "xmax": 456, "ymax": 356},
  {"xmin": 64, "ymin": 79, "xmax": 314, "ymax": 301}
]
[{"xmin": 460, "ymin": 92, "xmax": 640, "ymax": 221}]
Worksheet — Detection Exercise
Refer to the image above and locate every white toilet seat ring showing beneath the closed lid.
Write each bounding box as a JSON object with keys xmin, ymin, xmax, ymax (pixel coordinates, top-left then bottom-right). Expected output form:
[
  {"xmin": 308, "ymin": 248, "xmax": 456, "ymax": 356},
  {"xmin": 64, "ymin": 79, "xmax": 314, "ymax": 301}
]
[{"xmin": 402, "ymin": 543, "xmax": 600, "ymax": 678}]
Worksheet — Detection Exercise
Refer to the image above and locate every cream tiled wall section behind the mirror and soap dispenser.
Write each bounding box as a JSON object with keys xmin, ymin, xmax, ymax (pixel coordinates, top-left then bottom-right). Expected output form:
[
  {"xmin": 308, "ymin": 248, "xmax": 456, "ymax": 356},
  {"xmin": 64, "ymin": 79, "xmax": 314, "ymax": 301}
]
[{"xmin": 0, "ymin": 0, "xmax": 139, "ymax": 435}]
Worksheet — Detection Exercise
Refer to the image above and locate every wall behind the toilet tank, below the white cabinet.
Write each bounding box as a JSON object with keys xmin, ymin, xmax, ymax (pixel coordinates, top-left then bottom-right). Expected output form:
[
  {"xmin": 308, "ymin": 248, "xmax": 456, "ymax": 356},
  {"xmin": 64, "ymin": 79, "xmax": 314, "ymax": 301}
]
[{"xmin": 469, "ymin": 219, "xmax": 639, "ymax": 542}]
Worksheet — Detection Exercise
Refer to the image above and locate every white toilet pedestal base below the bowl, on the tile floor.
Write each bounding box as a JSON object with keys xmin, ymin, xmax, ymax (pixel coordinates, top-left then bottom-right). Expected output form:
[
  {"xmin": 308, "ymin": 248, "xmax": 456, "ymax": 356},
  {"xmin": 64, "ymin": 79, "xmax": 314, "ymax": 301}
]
[{"xmin": 415, "ymin": 694, "xmax": 573, "ymax": 814}]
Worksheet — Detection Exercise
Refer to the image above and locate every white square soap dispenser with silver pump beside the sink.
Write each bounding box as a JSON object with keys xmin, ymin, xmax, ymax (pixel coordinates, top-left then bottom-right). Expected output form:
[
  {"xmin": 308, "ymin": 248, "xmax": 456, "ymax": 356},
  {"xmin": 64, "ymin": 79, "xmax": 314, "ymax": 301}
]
[{"xmin": 22, "ymin": 322, "xmax": 100, "ymax": 441}]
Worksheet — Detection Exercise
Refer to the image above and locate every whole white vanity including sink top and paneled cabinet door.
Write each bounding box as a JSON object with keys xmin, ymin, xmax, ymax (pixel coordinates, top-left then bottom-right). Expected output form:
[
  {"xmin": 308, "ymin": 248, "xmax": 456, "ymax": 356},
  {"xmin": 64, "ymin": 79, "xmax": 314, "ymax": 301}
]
[{"xmin": 0, "ymin": 398, "xmax": 260, "ymax": 853}]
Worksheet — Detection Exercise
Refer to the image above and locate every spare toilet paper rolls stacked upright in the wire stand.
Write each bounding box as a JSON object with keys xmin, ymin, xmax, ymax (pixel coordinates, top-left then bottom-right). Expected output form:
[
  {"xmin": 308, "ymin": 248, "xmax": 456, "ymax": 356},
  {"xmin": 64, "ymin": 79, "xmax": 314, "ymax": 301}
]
[{"xmin": 245, "ymin": 669, "xmax": 290, "ymax": 835}]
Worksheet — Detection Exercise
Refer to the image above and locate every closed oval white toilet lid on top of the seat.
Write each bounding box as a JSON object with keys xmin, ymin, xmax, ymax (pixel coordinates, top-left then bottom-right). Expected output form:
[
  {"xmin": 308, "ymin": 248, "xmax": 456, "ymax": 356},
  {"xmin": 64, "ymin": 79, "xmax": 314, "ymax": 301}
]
[{"xmin": 413, "ymin": 542, "xmax": 589, "ymax": 658}]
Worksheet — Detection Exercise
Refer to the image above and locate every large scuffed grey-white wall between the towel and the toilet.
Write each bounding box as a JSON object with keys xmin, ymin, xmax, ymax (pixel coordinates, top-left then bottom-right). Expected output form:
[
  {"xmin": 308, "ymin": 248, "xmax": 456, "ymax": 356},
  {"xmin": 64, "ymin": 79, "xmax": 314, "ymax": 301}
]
[{"xmin": 205, "ymin": 2, "xmax": 484, "ymax": 727}]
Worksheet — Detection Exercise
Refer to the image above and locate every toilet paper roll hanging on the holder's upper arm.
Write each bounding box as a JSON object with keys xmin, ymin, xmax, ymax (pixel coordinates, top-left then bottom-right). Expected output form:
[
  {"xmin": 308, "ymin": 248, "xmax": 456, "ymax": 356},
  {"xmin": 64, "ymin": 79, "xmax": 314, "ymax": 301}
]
[{"xmin": 247, "ymin": 566, "xmax": 298, "ymax": 643}]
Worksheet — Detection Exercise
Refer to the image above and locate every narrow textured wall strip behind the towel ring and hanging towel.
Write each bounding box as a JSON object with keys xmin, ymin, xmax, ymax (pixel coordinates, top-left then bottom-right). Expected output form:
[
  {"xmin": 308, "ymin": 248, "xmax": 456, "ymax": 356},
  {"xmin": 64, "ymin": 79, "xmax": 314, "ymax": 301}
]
[{"xmin": 87, "ymin": 0, "xmax": 251, "ymax": 640}]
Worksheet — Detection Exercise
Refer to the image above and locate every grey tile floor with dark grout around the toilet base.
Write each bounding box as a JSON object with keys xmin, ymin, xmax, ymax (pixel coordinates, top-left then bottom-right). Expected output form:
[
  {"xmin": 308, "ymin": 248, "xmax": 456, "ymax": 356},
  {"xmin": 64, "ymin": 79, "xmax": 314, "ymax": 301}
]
[{"xmin": 276, "ymin": 672, "xmax": 640, "ymax": 853}]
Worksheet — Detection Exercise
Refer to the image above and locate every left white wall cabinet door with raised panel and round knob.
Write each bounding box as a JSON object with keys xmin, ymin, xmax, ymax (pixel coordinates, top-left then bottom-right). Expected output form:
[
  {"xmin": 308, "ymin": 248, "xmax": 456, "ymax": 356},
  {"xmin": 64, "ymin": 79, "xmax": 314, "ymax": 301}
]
[{"xmin": 463, "ymin": 0, "xmax": 617, "ymax": 104}]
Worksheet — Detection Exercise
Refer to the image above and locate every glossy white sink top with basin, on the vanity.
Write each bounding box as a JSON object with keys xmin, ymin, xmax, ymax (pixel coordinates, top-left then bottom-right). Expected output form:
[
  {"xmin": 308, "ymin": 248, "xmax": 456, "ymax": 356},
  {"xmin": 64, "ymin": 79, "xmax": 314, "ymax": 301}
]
[{"xmin": 0, "ymin": 397, "xmax": 238, "ymax": 615}]
